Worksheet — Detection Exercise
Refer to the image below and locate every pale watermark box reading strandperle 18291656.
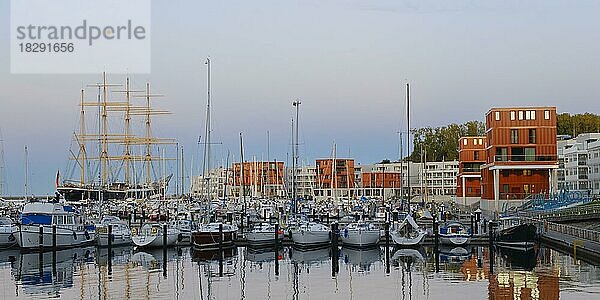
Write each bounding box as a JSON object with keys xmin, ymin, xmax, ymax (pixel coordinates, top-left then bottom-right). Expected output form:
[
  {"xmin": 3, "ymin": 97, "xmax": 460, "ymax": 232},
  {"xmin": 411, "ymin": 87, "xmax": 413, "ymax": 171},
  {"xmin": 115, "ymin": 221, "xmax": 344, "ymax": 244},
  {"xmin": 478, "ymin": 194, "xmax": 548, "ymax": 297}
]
[{"xmin": 10, "ymin": 0, "xmax": 150, "ymax": 73}]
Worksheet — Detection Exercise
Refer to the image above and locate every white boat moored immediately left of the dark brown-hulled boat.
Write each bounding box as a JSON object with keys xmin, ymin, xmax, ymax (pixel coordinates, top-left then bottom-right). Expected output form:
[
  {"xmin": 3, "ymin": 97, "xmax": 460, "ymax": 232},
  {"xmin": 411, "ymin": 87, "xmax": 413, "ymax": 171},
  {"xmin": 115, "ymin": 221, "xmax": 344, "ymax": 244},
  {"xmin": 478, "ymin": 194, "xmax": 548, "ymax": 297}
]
[{"xmin": 132, "ymin": 223, "xmax": 179, "ymax": 248}]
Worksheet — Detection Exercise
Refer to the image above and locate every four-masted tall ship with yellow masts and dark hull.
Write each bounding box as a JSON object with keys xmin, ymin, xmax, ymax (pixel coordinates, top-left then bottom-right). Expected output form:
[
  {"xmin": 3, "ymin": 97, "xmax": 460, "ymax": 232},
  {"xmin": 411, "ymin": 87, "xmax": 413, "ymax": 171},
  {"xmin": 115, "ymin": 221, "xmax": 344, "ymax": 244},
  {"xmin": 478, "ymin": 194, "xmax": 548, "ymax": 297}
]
[{"xmin": 56, "ymin": 73, "xmax": 175, "ymax": 202}]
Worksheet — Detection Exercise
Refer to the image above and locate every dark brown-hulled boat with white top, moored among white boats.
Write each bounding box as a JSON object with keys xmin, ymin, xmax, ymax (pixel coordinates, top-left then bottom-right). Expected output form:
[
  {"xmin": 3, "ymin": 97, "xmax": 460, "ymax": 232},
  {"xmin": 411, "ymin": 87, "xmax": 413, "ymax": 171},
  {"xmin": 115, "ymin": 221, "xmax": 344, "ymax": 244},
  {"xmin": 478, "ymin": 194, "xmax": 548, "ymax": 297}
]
[{"xmin": 192, "ymin": 222, "xmax": 237, "ymax": 250}]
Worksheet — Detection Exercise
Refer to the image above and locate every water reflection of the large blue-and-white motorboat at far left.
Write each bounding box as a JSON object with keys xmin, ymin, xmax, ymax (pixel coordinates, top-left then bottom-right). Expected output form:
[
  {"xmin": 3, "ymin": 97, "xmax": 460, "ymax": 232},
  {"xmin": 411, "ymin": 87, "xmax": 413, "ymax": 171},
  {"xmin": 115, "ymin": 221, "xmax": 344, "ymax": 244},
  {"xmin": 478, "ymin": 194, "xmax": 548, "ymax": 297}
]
[{"xmin": 12, "ymin": 247, "xmax": 96, "ymax": 297}]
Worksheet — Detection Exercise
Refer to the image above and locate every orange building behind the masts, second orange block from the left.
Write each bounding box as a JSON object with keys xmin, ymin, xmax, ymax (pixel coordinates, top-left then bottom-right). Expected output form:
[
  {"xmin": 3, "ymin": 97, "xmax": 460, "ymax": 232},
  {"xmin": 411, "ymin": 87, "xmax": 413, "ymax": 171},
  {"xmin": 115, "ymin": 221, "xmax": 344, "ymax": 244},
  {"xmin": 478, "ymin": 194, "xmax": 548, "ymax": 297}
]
[{"xmin": 316, "ymin": 158, "xmax": 354, "ymax": 189}]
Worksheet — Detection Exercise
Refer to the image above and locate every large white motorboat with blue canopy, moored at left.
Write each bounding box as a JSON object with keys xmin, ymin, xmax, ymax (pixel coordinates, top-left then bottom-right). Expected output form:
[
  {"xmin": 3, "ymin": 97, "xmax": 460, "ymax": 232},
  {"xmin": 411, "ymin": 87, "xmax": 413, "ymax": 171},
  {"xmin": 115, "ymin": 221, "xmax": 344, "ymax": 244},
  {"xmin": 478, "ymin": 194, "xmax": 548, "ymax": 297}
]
[{"xmin": 15, "ymin": 202, "xmax": 95, "ymax": 249}]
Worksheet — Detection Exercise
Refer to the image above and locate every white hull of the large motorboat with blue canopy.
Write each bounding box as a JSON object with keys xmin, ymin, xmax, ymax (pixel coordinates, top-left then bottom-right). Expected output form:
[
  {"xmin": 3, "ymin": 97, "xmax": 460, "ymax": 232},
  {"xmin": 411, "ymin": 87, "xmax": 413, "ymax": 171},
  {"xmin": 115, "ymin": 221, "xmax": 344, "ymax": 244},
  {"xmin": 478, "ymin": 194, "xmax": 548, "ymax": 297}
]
[{"xmin": 14, "ymin": 225, "xmax": 95, "ymax": 249}]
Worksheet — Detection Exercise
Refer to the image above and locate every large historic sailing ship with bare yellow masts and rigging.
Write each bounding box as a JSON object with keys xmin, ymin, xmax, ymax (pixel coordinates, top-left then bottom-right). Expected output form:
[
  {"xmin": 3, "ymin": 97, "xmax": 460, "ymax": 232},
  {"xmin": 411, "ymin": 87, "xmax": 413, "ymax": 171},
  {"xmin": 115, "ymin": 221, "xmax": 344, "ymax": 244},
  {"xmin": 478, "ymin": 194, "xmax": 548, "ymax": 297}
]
[{"xmin": 56, "ymin": 73, "xmax": 176, "ymax": 202}]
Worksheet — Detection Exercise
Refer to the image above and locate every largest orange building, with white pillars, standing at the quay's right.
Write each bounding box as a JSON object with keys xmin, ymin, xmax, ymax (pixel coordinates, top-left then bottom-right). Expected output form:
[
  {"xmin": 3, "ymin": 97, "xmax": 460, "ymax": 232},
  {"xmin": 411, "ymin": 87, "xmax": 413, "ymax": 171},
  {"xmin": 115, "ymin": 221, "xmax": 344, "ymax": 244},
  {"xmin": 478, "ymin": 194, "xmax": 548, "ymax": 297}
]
[{"xmin": 481, "ymin": 107, "xmax": 558, "ymax": 210}]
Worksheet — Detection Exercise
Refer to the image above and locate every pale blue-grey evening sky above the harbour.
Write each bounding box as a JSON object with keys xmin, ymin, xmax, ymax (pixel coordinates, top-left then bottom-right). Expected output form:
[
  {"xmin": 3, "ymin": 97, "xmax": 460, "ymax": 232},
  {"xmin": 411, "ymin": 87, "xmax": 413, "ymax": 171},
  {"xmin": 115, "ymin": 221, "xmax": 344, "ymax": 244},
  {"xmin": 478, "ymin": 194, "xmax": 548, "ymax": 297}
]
[{"xmin": 0, "ymin": 0, "xmax": 600, "ymax": 195}]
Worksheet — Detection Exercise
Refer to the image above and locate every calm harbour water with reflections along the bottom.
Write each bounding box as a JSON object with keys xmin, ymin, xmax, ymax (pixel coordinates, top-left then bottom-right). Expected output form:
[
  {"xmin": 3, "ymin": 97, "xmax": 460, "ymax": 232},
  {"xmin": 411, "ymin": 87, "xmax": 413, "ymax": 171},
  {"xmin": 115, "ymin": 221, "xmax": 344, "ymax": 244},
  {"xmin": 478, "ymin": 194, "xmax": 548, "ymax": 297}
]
[{"xmin": 0, "ymin": 247, "xmax": 600, "ymax": 300}]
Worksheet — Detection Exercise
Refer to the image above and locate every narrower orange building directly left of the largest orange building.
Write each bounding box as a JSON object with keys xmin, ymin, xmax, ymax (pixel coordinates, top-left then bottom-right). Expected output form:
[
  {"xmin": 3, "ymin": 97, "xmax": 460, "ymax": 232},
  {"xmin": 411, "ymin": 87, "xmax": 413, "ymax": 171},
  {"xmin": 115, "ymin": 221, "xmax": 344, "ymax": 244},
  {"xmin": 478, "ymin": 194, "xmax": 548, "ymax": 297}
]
[{"xmin": 456, "ymin": 136, "xmax": 486, "ymax": 202}]
